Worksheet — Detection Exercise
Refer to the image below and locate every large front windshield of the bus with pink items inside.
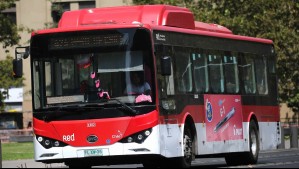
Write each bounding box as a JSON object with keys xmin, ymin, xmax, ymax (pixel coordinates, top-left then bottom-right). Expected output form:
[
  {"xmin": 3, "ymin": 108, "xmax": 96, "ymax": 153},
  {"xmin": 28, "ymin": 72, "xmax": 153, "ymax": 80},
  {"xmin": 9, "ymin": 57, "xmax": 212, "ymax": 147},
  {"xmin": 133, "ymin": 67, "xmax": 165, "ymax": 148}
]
[{"xmin": 31, "ymin": 29, "xmax": 155, "ymax": 109}]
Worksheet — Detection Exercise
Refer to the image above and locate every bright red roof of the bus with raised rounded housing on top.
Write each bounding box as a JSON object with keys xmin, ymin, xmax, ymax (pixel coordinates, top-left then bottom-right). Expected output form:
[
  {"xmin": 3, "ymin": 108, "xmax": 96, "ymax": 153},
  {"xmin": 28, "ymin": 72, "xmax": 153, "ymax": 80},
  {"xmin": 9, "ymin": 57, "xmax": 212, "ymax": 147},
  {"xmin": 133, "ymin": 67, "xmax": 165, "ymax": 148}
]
[{"xmin": 35, "ymin": 5, "xmax": 273, "ymax": 44}]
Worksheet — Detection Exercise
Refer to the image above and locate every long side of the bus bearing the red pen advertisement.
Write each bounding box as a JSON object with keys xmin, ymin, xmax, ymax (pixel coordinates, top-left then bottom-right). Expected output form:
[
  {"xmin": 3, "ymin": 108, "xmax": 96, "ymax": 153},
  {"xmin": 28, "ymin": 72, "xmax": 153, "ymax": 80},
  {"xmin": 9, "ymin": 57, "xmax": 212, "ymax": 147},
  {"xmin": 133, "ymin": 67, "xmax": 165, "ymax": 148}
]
[{"xmin": 153, "ymin": 31, "xmax": 280, "ymax": 157}]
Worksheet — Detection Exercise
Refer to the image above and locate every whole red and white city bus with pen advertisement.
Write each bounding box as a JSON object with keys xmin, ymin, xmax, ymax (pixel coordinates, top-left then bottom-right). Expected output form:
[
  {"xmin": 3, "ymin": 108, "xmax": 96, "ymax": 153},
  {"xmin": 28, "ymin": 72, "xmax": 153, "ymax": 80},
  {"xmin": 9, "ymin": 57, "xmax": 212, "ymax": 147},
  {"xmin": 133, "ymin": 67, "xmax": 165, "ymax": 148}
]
[{"xmin": 14, "ymin": 5, "xmax": 281, "ymax": 167}]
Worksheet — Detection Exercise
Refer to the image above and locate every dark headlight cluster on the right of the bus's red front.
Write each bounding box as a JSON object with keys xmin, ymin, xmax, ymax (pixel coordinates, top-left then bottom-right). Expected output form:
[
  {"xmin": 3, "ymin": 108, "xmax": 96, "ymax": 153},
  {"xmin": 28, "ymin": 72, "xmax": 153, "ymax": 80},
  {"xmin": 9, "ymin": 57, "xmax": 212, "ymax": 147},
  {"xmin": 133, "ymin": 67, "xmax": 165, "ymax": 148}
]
[{"xmin": 120, "ymin": 129, "xmax": 152, "ymax": 144}]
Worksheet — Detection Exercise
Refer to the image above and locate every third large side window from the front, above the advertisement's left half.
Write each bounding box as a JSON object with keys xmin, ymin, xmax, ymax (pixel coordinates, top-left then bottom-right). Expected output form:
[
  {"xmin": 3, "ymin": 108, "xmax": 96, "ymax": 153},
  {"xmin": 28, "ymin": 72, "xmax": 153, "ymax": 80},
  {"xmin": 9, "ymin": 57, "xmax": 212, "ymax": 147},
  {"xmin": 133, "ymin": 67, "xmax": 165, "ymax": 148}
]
[{"xmin": 208, "ymin": 53, "xmax": 224, "ymax": 93}]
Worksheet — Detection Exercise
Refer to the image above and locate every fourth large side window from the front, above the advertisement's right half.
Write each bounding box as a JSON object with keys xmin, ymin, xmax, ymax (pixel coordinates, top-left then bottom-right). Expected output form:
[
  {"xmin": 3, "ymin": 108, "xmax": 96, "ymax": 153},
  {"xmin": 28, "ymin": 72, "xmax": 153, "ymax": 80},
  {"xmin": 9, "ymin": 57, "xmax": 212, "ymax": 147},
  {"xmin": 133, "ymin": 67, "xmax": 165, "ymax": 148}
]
[{"xmin": 224, "ymin": 53, "xmax": 239, "ymax": 93}]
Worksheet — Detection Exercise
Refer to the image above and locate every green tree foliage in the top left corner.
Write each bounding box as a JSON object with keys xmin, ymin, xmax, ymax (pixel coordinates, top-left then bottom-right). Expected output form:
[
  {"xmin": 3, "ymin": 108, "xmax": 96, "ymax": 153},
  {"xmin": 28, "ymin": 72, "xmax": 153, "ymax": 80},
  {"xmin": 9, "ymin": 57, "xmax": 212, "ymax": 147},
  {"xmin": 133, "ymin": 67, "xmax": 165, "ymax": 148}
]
[{"xmin": 0, "ymin": 0, "xmax": 20, "ymax": 48}]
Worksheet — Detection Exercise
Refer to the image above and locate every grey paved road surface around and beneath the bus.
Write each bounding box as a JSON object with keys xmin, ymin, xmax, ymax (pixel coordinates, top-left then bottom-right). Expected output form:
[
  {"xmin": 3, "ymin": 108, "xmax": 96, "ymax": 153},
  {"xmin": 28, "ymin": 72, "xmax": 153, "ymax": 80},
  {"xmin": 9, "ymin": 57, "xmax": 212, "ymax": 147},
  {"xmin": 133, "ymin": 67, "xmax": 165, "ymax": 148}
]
[{"xmin": 2, "ymin": 140, "xmax": 299, "ymax": 168}]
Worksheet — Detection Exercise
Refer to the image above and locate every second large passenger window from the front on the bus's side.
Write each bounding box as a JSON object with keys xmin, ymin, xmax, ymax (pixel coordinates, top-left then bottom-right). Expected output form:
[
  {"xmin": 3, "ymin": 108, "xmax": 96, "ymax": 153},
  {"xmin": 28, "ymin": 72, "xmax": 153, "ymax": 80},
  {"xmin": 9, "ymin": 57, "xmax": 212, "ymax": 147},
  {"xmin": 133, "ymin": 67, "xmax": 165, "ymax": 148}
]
[{"xmin": 192, "ymin": 53, "xmax": 209, "ymax": 93}]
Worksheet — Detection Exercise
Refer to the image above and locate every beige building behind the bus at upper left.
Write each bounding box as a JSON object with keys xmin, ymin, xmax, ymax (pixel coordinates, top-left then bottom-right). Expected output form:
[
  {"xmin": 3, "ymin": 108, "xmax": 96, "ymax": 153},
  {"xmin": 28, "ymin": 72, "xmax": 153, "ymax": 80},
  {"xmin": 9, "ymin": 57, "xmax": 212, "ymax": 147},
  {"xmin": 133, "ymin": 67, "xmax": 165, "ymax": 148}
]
[{"xmin": 0, "ymin": 0, "xmax": 132, "ymax": 128}]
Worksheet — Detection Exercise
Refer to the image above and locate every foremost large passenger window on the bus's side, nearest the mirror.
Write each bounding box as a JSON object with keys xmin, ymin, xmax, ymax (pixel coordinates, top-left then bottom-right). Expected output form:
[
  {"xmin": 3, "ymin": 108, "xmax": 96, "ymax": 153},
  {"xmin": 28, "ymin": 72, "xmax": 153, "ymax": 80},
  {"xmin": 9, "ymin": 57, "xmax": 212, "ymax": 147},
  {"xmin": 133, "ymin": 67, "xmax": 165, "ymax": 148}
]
[{"xmin": 174, "ymin": 47, "xmax": 192, "ymax": 93}]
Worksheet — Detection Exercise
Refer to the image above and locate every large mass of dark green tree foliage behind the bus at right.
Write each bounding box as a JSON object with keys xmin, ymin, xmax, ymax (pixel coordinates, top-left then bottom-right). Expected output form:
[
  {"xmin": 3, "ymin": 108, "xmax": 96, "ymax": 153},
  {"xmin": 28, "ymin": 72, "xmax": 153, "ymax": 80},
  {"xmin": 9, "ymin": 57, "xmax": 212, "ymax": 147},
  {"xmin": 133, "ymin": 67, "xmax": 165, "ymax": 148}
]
[{"xmin": 133, "ymin": 0, "xmax": 299, "ymax": 112}]
